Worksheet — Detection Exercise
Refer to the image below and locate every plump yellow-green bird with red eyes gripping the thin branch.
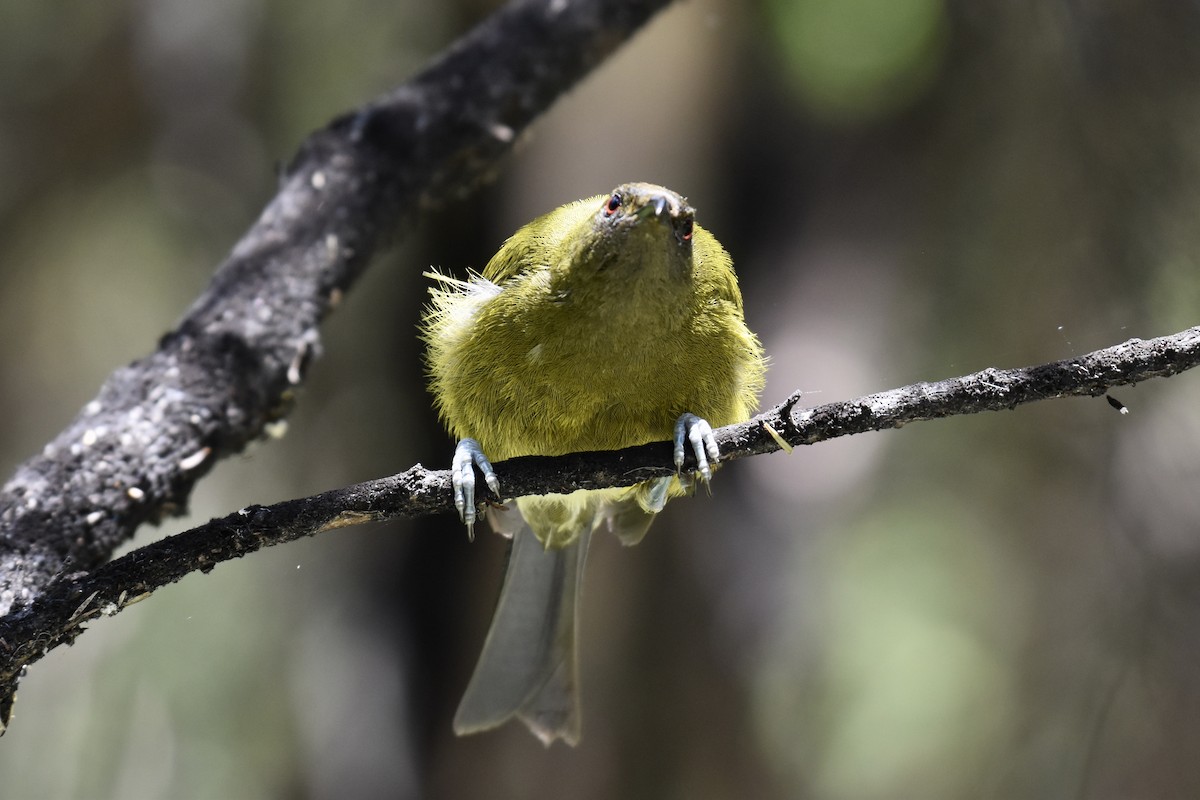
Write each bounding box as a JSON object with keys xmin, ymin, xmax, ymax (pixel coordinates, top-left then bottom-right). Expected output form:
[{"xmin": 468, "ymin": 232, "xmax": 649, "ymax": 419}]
[{"xmin": 422, "ymin": 184, "xmax": 764, "ymax": 745}]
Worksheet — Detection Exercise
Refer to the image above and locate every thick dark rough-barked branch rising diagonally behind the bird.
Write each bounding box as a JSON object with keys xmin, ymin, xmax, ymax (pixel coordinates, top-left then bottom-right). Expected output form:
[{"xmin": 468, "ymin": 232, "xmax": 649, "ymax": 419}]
[{"xmin": 0, "ymin": 0, "xmax": 668, "ymax": 618}]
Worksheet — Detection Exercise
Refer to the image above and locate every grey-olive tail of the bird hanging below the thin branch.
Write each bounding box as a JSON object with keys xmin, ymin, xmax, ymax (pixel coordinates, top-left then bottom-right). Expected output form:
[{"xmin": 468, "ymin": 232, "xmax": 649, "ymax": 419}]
[{"xmin": 454, "ymin": 509, "xmax": 592, "ymax": 746}]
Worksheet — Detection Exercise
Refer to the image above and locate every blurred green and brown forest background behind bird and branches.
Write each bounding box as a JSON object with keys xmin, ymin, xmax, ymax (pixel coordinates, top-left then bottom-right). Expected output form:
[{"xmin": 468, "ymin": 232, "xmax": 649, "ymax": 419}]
[{"xmin": 0, "ymin": 0, "xmax": 1200, "ymax": 800}]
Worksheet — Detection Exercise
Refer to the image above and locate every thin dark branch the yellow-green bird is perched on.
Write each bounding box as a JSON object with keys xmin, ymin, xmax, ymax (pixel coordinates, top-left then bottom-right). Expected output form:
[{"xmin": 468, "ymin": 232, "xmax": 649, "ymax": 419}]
[{"xmin": 0, "ymin": 327, "xmax": 1200, "ymax": 702}]
